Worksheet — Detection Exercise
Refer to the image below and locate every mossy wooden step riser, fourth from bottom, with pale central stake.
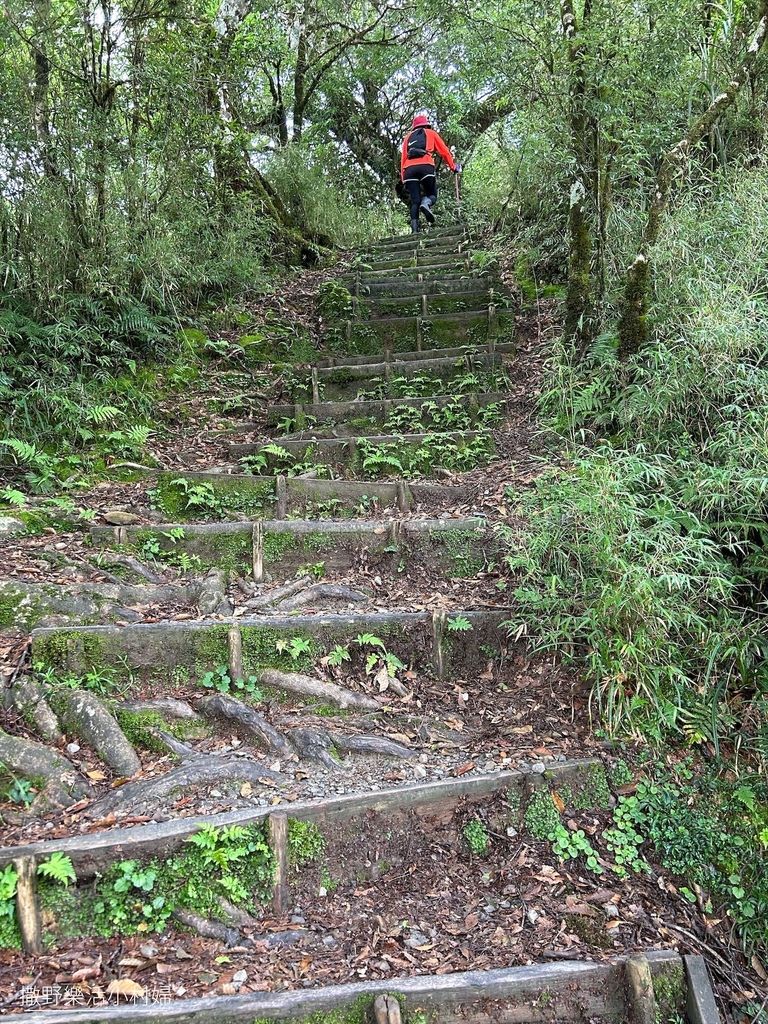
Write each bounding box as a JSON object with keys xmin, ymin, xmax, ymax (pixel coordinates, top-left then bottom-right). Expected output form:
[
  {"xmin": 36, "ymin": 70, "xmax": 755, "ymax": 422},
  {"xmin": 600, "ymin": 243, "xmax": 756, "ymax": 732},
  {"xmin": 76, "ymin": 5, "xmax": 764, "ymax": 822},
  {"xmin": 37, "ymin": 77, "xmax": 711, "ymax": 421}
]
[{"xmin": 93, "ymin": 518, "xmax": 499, "ymax": 581}]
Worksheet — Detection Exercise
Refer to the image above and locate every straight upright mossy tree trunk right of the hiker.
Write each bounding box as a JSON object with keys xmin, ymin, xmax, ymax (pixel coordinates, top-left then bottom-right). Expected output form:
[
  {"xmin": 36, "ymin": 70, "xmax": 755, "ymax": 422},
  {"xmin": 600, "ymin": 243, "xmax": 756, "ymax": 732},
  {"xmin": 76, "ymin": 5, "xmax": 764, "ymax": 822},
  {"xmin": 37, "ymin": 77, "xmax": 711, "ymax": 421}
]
[{"xmin": 560, "ymin": 0, "xmax": 595, "ymax": 357}]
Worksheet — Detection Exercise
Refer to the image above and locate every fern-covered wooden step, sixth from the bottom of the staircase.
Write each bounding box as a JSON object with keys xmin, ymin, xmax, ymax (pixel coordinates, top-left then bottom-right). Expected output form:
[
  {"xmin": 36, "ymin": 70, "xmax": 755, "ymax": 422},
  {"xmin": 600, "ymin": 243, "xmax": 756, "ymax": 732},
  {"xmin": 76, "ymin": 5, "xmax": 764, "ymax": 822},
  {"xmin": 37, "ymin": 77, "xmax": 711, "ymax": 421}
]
[{"xmin": 227, "ymin": 430, "xmax": 496, "ymax": 480}]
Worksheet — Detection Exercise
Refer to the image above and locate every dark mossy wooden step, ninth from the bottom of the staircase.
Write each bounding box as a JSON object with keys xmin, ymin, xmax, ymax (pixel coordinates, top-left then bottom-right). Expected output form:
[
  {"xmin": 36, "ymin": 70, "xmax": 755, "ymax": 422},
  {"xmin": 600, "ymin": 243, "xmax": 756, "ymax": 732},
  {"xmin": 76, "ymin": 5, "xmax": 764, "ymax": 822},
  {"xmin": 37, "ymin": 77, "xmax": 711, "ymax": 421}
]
[{"xmin": 331, "ymin": 307, "xmax": 515, "ymax": 355}]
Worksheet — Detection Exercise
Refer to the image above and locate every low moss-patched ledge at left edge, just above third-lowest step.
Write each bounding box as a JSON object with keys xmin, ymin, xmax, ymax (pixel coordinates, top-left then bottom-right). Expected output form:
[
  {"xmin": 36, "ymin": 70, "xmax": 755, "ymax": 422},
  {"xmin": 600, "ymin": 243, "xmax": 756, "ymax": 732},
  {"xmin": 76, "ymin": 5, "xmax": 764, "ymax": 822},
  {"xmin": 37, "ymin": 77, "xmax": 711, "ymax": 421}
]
[{"xmin": 0, "ymin": 580, "xmax": 207, "ymax": 631}]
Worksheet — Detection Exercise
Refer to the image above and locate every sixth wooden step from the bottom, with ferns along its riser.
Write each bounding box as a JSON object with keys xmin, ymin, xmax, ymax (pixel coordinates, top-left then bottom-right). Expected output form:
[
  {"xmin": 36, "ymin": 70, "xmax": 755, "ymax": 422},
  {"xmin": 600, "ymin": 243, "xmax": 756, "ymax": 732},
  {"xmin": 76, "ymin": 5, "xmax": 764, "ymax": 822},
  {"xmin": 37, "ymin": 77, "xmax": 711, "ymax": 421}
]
[{"xmin": 226, "ymin": 430, "xmax": 496, "ymax": 479}]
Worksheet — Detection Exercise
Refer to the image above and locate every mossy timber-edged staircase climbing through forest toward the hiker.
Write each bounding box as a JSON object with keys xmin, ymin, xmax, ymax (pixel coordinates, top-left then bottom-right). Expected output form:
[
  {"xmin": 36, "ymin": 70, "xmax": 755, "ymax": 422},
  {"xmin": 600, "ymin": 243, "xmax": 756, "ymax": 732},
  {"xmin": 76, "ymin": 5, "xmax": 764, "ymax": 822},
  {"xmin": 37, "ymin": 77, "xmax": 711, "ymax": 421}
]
[{"xmin": 0, "ymin": 224, "xmax": 717, "ymax": 1024}]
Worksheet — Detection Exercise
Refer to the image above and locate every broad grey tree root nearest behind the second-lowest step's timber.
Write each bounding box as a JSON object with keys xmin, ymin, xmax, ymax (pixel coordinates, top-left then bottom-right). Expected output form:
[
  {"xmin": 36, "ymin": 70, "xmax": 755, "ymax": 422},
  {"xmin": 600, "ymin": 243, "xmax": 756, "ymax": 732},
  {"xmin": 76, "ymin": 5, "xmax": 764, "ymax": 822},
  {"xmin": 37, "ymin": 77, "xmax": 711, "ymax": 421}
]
[{"xmin": 83, "ymin": 754, "xmax": 286, "ymax": 817}]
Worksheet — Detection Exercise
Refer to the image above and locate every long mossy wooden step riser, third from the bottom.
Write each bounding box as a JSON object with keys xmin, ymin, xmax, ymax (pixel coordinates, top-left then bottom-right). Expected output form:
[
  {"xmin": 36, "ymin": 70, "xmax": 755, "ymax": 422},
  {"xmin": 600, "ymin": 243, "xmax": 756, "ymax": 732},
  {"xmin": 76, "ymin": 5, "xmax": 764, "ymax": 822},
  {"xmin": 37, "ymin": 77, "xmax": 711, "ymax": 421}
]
[{"xmin": 32, "ymin": 608, "xmax": 510, "ymax": 687}]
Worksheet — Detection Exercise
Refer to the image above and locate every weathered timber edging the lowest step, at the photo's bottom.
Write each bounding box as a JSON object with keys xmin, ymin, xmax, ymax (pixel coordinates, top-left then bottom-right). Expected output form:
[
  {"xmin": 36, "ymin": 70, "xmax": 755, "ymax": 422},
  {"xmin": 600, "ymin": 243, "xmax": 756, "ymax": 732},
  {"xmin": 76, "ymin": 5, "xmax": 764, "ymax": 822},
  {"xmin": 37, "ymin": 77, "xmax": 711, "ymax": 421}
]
[{"xmin": 26, "ymin": 950, "xmax": 682, "ymax": 1024}]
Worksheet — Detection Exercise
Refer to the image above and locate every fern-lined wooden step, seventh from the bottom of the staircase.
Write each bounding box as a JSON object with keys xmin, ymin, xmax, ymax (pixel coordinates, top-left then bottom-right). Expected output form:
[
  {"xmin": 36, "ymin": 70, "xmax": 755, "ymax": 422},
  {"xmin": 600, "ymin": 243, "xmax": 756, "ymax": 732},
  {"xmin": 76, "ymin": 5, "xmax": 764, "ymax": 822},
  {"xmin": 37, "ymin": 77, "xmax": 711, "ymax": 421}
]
[{"xmin": 264, "ymin": 391, "xmax": 507, "ymax": 428}]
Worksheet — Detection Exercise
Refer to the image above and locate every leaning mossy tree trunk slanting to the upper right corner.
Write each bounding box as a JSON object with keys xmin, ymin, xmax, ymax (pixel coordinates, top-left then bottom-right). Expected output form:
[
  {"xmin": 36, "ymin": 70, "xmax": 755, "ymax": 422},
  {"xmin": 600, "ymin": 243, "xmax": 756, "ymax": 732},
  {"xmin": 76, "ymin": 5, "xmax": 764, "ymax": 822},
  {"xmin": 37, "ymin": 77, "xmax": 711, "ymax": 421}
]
[{"xmin": 618, "ymin": 0, "xmax": 768, "ymax": 359}]
